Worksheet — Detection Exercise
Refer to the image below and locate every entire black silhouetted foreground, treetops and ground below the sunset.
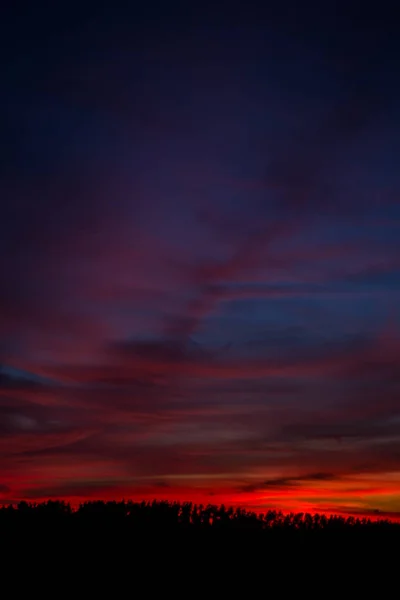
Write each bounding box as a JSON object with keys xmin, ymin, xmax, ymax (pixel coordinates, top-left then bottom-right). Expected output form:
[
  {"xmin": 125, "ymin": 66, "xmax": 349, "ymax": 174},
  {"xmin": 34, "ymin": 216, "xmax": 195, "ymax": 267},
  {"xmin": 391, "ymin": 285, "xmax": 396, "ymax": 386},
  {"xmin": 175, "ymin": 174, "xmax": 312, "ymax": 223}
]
[{"xmin": 0, "ymin": 502, "xmax": 400, "ymax": 598}]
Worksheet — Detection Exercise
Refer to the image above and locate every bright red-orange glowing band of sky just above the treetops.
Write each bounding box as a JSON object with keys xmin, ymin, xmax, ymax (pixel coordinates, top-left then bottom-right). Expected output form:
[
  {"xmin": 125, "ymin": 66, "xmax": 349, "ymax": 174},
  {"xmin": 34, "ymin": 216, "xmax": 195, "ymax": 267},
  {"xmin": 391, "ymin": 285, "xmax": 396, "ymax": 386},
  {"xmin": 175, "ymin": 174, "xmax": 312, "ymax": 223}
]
[{"xmin": 5, "ymin": 468, "xmax": 400, "ymax": 521}]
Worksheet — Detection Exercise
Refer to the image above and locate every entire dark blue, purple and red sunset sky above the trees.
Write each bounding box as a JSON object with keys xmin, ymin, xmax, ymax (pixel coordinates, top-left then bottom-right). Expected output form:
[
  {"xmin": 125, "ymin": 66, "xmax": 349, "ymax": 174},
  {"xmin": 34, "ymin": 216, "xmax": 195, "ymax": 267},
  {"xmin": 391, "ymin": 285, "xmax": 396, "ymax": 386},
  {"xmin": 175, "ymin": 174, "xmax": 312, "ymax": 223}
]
[{"xmin": 0, "ymin": 0, "xmax": 400, "ymax": 518}]
